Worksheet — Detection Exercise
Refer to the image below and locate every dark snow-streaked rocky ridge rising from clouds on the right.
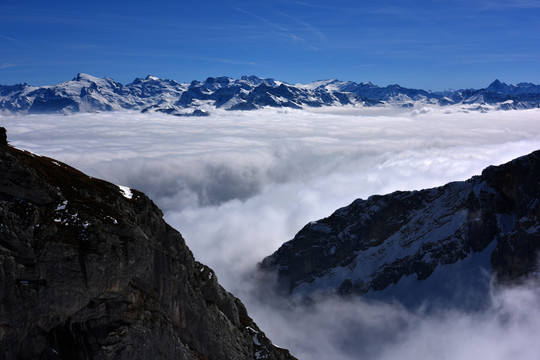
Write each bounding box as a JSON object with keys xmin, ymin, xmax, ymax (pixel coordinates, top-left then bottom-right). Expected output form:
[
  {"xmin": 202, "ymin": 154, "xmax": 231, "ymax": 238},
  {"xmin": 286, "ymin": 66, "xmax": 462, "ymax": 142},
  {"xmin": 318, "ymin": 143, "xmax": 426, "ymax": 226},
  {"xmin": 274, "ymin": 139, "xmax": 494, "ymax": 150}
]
[{"xmin": 260, "ymin": 151, "xmax": 540, "ymax": 296}]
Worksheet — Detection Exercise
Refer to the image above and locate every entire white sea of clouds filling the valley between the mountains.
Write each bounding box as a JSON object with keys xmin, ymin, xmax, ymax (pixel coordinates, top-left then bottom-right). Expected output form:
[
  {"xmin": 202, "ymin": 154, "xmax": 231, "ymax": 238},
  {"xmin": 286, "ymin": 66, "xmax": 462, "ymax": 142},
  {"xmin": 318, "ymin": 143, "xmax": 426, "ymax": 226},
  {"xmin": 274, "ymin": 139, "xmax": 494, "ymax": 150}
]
[{"xmin": 4, "ymin": 107, "xmax": 540, "ymax": 360}]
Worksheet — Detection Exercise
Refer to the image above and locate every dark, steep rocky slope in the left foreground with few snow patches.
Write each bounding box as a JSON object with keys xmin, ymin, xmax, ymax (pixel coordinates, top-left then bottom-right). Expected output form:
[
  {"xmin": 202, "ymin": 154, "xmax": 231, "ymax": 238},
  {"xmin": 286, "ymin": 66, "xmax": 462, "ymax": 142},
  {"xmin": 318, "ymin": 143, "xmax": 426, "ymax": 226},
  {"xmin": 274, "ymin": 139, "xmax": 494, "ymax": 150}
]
[{"xmin": 0, "ymin": 146, "xmax": 293, "ymax": 359}]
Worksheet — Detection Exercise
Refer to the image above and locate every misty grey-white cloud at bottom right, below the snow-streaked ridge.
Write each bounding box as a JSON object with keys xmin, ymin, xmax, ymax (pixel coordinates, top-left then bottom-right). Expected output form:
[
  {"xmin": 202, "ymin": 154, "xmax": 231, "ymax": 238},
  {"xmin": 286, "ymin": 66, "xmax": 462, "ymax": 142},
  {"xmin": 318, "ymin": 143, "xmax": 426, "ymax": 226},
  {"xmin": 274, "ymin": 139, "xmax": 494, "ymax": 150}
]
[{"xmin": 242, "ymin": 285, "xmax": 540, "ymax": 360}]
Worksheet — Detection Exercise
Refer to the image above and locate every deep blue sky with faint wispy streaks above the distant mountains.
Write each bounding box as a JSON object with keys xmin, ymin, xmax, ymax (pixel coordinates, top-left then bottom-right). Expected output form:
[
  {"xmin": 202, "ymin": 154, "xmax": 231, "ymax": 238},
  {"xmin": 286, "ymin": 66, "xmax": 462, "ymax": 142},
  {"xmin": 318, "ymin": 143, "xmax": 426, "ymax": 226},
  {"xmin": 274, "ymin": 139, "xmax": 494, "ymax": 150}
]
[{"xmin": 0, "ymin": 0, "xmax": 540, "ymax": 90}]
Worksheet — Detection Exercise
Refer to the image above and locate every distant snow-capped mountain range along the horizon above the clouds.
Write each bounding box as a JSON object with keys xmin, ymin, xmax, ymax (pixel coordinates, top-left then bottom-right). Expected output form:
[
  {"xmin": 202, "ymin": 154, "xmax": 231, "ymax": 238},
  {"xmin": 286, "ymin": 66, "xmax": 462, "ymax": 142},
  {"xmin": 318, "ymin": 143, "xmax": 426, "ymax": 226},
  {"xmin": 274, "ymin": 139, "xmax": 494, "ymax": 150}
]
[{"xmin": 0, "ymin": 74, "xmax": 540, "ymax": 116}]
